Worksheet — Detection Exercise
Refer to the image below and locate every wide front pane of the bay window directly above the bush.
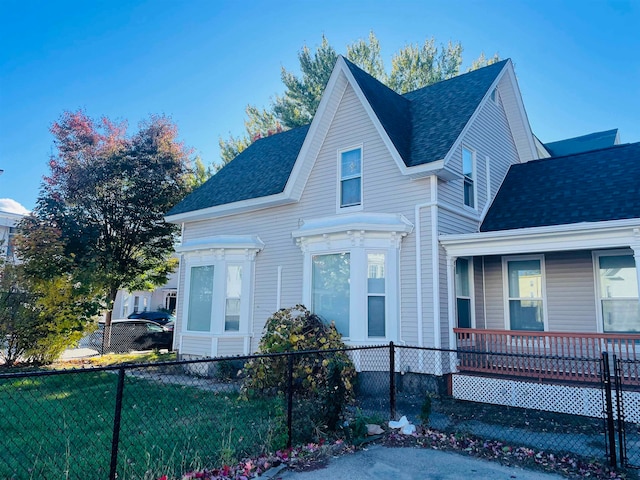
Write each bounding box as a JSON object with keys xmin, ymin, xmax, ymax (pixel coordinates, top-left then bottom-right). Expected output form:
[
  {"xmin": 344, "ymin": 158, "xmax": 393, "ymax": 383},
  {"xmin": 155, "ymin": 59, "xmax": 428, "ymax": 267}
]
[{"xmin": 311, "ymin": 253, "xmax": 351, "ymax": 337}]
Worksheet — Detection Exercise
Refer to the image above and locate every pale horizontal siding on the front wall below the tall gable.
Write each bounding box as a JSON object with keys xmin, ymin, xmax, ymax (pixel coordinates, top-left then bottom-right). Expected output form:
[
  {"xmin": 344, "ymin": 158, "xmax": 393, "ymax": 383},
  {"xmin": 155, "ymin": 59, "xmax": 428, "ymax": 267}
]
[{"xmin": 177, "ymin": 81, "xmax": 431, "ymax": 354}]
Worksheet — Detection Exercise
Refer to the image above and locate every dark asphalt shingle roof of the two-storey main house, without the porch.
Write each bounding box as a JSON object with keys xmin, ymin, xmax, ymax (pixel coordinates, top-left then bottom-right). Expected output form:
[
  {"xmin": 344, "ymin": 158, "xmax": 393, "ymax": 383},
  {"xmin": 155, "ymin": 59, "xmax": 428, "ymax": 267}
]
[{"xmin": 167, "ymin": 59, "xmax": 507, "ymax": 216}]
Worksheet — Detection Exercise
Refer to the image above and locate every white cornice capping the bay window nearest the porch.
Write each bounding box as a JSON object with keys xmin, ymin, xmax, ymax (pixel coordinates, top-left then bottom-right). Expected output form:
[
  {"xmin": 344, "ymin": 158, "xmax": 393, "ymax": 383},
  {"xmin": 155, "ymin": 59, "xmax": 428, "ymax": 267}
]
[{"xmin": 291, "ymin": 213, "xmax": 413, "ymax": 238}]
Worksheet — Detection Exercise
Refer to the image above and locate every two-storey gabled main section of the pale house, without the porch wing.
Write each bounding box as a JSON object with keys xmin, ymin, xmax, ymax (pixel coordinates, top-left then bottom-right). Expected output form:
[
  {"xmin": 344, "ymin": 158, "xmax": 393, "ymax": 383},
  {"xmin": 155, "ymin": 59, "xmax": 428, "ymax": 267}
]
[{"xmin": 167, "ymin": 57, "xmax": 543, "ymax": 358}]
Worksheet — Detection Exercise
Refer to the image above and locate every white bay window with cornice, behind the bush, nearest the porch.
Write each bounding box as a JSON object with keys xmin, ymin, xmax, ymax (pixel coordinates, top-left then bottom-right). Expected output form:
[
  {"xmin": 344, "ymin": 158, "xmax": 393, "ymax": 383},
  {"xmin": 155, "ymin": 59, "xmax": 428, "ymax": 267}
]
[{"xmin": 292, "ymin": 212, "xmax": 413, "ymax": 345}]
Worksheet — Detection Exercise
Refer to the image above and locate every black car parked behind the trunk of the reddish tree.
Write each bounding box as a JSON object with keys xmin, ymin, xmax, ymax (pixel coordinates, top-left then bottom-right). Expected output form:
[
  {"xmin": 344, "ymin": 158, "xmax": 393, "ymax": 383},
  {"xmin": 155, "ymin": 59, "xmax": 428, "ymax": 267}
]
[{"xmin": 89, "ymin": 318, "xmax": 173, "ymax": 353}]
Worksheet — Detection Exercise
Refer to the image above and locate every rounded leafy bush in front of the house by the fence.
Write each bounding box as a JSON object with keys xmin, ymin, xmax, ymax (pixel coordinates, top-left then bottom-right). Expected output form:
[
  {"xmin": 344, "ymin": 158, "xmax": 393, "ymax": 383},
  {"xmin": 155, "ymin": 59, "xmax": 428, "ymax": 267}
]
[{"xmin": 243, "ymin": 305, "xmax": 356, "ymax": 438}]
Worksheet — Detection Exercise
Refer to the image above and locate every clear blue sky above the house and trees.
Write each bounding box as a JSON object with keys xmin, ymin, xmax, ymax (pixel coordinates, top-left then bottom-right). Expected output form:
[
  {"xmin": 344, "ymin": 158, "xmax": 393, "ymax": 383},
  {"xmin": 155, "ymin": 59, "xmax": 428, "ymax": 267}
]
[{"xmin": 0, "ymin": 0, "xmax": 640, "ymax": 209}]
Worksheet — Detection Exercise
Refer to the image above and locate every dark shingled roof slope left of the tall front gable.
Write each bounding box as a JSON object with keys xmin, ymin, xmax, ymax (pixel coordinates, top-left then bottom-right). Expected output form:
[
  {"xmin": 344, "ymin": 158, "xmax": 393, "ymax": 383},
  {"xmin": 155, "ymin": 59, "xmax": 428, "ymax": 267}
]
[{"xmin": 167, "ymin": 125, "xmax": 309, "ymax": 216}]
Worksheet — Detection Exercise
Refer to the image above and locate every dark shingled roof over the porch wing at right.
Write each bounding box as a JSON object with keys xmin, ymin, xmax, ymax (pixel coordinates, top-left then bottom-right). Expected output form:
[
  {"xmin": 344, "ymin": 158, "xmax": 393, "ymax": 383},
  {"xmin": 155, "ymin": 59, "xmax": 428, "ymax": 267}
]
[{"xmin": 480, "ymin": 143, "xmax": 640, "ymax": 232}]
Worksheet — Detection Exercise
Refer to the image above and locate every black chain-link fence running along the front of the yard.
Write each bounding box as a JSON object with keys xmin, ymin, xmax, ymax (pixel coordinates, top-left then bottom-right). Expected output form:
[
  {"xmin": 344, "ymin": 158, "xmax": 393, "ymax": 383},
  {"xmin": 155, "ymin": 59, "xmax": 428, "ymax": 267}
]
[{"xmin": 0, "ymin": 344, "xmax": 640, "ymax": 479}]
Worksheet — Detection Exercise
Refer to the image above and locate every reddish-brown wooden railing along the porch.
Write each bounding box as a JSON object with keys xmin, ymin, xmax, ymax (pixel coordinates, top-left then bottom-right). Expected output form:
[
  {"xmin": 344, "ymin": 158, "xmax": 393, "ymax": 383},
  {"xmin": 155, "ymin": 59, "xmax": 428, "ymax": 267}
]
[{"xmin": 453, "ymin": 328, "xmax": 640, "ymax": 384}]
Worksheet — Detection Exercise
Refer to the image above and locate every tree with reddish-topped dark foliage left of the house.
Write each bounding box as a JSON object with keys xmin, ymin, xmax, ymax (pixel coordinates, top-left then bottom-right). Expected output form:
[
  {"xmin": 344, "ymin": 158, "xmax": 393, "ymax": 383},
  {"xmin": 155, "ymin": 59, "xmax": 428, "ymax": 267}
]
[{"xmin": 18, "ymin": 111, "xmax": 192, "ymax": 344}]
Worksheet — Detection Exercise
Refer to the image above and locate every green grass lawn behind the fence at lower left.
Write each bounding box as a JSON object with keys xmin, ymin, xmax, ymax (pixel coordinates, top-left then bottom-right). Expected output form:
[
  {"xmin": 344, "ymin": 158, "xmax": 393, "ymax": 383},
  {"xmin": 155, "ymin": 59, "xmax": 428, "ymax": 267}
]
[{"xmin": 0, "ymin": 372, "xmax": 286, "ymax": 480}]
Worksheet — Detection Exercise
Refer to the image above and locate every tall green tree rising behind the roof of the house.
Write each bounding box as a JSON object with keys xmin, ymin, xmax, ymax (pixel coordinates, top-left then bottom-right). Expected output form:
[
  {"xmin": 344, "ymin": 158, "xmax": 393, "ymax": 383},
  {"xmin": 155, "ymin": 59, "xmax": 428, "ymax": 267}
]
[{"xmin": 219, "ymin": 32, "xmax": 499, "ymax": 165}]
